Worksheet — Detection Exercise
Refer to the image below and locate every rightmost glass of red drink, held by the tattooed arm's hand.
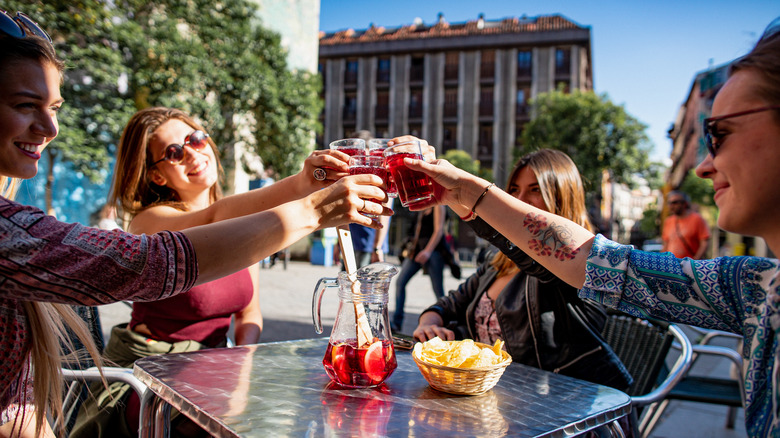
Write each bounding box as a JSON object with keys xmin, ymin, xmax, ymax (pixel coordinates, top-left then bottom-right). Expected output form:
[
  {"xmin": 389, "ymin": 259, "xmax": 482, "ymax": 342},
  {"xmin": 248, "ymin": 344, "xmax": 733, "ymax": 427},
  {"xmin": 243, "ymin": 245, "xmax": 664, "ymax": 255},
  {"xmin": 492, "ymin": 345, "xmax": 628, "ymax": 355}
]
[{"xmin": 385, "ymin": 141, "xmax": 433, "ymax": 207}]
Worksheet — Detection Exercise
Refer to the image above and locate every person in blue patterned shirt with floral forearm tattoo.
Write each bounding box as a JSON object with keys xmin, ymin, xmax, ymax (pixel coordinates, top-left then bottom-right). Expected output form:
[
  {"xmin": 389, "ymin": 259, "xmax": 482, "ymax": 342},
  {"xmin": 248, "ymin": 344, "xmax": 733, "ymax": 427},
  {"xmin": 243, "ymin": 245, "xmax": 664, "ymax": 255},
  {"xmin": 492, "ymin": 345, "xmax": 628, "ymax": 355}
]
[{"xmin": 407, "ymin": 19, "xmax": 780, "ymax": 437}]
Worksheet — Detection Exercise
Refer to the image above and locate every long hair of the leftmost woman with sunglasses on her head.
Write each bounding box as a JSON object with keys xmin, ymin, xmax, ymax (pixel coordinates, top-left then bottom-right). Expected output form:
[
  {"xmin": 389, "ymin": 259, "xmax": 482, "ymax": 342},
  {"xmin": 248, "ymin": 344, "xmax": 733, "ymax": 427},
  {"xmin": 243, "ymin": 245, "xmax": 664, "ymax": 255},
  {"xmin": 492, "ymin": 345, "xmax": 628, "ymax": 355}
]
[{"xmin": 0, "ymin": 35, "xmax": 105, "ymax": 435}]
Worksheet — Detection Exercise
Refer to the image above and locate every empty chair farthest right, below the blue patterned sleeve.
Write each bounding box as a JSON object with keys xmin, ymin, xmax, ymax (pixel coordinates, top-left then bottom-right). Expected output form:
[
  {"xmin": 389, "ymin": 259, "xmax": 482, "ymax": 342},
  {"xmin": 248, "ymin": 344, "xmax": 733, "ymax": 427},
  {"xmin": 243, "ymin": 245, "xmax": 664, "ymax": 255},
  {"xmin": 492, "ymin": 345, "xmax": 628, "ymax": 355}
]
[{"xmin": 648, "ymin": 326, "xmax": 745, "ymax": 430}]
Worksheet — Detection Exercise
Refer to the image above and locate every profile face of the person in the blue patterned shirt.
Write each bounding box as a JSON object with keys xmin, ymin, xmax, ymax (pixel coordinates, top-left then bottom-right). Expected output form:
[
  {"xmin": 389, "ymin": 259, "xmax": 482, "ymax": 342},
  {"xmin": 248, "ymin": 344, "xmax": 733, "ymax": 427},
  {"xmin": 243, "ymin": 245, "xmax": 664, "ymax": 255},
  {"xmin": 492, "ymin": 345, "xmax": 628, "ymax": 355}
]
[{"xmin": 696, "ymin": 69, "xmax": 780, "ymax": 245}]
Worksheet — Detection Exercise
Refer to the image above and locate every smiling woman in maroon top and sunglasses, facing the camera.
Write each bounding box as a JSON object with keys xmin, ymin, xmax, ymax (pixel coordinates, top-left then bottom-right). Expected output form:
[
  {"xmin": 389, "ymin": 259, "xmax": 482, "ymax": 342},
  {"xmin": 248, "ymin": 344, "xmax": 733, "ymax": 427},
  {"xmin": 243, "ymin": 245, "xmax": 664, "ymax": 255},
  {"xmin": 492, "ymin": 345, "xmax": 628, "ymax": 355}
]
[{"xmin": 72, "ymin": 107, "xmax": 356, "ymax": 437}]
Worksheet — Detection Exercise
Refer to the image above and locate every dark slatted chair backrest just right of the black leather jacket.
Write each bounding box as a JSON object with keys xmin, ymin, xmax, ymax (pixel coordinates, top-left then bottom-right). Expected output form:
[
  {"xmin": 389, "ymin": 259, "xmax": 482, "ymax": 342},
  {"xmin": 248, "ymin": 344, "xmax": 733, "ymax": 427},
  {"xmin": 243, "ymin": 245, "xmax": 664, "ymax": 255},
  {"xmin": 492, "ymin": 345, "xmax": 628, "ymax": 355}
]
[{"xmin": 602, "ymin": 312, "xmax": 674, "ymax": 397}]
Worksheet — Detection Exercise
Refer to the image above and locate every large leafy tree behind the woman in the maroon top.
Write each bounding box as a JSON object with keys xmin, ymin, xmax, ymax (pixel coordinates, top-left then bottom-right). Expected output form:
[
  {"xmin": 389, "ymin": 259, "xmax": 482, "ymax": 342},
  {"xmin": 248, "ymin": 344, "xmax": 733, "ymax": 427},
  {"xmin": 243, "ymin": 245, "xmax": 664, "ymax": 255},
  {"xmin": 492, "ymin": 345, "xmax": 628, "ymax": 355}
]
[{"xmin": 112, "ymin": 0, "xmax": 320, "ymax": 186}]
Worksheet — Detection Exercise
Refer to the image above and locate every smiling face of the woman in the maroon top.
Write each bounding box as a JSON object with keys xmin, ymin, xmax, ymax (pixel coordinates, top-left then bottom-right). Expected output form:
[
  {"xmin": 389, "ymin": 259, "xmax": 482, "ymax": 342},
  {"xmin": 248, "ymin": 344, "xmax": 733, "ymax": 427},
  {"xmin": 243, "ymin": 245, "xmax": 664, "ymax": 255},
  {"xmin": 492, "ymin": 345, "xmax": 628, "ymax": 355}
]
[{"xmin": 148, "ymin": 119, "xmax": 218, "ymax": 207}]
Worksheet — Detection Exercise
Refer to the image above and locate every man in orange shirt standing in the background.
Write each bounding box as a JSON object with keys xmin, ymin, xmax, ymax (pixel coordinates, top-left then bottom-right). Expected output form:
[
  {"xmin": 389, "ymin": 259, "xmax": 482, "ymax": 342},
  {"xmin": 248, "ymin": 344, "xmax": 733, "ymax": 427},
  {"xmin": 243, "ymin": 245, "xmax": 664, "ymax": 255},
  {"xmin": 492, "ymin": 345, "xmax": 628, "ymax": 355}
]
[{"xmin": 661, "ymin": 190, "xmax": 710, "ymax": 259}]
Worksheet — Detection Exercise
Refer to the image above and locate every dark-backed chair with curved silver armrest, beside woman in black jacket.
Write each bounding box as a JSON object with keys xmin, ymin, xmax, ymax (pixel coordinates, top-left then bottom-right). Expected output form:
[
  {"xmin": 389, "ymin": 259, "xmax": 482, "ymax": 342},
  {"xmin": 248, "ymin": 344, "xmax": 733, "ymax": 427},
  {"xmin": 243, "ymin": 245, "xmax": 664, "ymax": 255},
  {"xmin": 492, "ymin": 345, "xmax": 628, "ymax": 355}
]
[{"xmin": 602, "ymin": 311, "xmax": 692, "ymax": 437}]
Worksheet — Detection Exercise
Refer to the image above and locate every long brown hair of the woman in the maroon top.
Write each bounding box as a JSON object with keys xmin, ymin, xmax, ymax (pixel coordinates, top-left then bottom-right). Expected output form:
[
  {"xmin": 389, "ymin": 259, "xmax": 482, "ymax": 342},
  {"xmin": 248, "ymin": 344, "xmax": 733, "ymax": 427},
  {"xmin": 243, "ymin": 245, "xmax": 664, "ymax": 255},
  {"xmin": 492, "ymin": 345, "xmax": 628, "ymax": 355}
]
[{"xmin": 108, "ymin": 107, "xmax": 223, "ymax": 216}]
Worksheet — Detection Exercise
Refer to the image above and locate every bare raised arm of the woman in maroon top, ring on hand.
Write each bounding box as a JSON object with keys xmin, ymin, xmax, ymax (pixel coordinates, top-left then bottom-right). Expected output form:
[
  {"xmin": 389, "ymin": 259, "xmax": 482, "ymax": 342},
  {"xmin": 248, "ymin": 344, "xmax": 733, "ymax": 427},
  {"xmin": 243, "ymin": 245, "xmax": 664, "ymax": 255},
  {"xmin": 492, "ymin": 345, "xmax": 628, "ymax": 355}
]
[{"xmin": 129, "ymin": 150, "xmax": 349, "ymax": 234}]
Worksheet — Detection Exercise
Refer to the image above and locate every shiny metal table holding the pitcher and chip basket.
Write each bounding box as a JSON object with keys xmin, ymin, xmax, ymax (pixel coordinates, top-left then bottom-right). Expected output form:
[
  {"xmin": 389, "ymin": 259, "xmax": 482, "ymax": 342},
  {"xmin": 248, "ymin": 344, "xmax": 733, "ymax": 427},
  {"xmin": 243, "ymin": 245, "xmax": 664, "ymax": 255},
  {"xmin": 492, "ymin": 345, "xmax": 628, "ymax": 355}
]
[{"xmin": 134, "ymin": 338, "xmax": 631, "ymax": 437}]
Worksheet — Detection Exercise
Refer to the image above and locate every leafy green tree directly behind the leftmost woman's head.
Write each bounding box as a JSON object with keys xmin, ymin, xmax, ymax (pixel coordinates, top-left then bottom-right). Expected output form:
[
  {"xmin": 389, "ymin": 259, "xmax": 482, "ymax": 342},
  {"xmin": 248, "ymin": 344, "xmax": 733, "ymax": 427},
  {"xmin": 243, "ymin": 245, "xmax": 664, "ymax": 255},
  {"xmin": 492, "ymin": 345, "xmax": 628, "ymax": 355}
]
[{"xmin": 4, "ymin": 0, "xmax": 133, "ymax": 211}]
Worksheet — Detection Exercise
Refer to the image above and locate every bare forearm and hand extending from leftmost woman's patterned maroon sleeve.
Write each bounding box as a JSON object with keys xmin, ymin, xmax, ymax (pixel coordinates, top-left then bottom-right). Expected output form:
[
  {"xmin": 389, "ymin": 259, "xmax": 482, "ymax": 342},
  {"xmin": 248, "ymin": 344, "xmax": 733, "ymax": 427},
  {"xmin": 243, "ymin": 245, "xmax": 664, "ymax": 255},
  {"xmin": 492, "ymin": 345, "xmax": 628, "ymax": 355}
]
[{"xmin": 182, "ymin": 175, "xmax": 391, "ymax": 284}]
